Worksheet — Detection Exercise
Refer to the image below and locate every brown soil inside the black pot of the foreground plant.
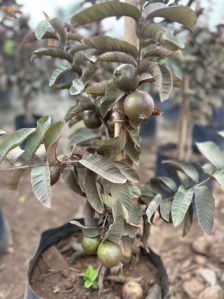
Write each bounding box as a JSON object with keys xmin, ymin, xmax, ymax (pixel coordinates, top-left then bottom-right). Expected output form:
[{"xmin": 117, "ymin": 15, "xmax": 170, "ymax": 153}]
[{"xmin": 31, "ymin": 235, "xmax": 160, "ymax": 299}]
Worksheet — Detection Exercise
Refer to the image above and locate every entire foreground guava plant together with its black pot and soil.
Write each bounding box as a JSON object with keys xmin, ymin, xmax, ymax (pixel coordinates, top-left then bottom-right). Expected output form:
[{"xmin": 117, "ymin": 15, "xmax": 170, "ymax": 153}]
[{"xmin": 0, "ymin": 1, "xmax": 224, "ymax": 298}]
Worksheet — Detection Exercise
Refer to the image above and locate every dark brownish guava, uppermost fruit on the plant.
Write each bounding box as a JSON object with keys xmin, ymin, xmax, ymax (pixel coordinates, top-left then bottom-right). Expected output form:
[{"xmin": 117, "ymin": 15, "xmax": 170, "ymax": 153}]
[{"xmin": 113, "ymin": 64, "xmax": 139, "ymax": 92}]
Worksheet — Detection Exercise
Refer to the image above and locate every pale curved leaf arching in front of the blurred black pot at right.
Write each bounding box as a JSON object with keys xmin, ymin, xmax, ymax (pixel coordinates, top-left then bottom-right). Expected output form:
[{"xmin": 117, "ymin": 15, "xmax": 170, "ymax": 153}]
[{"xmin": 163, "ymin": 160, "xmax": 199, "ymax": 183}]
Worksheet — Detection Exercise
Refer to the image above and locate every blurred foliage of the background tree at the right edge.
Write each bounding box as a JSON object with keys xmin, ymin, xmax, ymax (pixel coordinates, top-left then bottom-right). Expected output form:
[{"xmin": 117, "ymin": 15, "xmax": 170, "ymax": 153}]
[{"xmin": 170, "ymin": 25, "xmax": 224, "ymax": 122}]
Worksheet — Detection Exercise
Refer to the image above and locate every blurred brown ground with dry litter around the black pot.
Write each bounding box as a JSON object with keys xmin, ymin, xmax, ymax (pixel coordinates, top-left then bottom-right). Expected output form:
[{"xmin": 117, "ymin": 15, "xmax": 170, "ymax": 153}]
[{"xmin": 0, "ymin": 105, "xmax": 224, "ymax": 299}]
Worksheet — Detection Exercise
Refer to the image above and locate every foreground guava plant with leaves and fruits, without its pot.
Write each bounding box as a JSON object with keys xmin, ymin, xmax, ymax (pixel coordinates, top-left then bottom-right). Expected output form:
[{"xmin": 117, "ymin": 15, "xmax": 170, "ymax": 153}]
[{"xmin": 0, "ymin": 1, "xmax": 224, "ymax": 296}]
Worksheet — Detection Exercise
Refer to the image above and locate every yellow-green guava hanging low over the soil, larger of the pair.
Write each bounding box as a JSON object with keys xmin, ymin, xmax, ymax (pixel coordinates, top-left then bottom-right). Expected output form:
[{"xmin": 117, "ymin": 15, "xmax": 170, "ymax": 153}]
[{"xmin": 97, "ymin": 241, "xmax": 122, "ymax": 268}]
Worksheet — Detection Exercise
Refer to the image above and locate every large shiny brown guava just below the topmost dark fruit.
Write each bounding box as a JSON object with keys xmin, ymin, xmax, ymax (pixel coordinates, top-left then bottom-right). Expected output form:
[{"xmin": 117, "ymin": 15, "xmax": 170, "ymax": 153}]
[{"xmin": 124, "ymin": 90, "xmax": 154, "ymax": 125}]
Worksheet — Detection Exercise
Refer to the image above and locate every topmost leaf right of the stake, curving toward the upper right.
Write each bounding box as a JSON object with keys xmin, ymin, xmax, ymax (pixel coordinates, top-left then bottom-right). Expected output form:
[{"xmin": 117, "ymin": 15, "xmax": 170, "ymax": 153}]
[{"xmin": 144, "ymin": 3, "xmax": 197, "ymax": 30}]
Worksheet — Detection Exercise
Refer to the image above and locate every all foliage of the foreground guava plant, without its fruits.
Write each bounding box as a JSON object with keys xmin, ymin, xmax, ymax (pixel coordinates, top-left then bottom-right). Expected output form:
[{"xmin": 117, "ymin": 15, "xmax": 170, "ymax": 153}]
[{"xmin": 0, "ymin": 1, "xmax": 220, "ymax": 264}]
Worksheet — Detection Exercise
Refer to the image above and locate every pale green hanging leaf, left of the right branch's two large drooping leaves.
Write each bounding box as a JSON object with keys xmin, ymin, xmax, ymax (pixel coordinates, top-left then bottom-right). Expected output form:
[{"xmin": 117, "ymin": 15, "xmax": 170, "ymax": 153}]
[{"xmin": 171, "ymin": 186, "xmax": 194, "ymax": 227}]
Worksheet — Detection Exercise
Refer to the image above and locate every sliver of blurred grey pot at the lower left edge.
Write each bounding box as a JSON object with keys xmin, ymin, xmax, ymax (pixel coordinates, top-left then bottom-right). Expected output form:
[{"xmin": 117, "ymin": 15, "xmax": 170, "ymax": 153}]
[{"xmin": 0, "ymin": 209, "xmax": 11, "ymax": 255}]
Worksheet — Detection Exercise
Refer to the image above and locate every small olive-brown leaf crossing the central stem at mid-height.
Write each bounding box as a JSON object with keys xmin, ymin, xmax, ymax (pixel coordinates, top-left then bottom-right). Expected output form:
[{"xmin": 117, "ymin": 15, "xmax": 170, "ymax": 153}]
[{"xmin": 97, "ymin": 137, "xmax": 125, "ymax": 158}]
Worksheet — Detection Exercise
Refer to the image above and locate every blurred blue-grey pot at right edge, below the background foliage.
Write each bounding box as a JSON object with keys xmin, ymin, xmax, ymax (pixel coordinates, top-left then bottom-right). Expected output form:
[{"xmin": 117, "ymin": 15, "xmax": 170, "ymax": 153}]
[{"xmin": 193, "ymin": 125, "xmax": 224, "ymax": 153}]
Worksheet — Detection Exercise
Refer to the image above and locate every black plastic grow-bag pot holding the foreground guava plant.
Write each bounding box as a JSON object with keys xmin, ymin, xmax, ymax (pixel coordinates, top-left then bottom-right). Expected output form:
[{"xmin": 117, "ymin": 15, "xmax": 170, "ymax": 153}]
[{"xmin": 24, "ymin": 220, "xmax": 169, "ymax": 299}]
